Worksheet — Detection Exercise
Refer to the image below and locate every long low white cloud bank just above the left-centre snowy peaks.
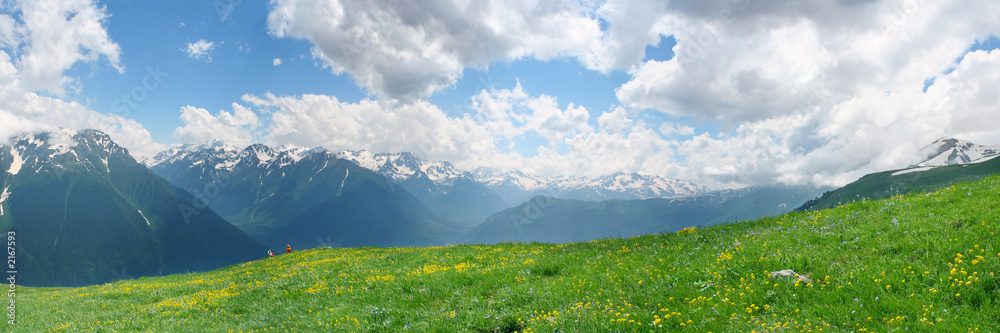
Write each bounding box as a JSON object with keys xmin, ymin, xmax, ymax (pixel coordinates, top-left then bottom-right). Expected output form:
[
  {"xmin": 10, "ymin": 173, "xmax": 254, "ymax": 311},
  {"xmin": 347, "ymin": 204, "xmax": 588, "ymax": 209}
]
[{"xmin": 243, "ymin": 94, "xmax": 492, "ymax": 161}]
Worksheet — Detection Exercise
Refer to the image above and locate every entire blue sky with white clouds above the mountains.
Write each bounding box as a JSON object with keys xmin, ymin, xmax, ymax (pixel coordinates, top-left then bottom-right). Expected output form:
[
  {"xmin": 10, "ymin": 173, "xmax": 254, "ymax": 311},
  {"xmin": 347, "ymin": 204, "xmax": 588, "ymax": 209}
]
[{"xmin": 0, "ymin": 0, "xmax": 1000, "ymax": 187}]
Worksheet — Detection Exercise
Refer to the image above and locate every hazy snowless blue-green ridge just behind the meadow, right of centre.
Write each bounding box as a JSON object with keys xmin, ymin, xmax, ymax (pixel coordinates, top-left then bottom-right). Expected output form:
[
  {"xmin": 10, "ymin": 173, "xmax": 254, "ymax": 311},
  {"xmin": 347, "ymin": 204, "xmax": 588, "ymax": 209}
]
[{"xmin": 463, "ymin": 186, "xmax": 824, "ymax": 243}]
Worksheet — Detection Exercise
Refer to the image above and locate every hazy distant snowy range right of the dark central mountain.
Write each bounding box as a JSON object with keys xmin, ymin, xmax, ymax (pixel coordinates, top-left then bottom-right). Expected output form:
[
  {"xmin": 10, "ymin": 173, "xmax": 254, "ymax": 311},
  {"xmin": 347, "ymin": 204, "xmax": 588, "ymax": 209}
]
[{"xmin": 337, "ymin": 151, "xmax": 707, "ymax": 210}]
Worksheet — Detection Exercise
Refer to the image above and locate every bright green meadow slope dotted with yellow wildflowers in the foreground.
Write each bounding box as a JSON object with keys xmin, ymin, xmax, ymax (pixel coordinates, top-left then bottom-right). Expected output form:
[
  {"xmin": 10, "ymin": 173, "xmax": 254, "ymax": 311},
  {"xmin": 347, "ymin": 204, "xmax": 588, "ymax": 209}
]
[{"xmin": 17, "ymin": 176, "xmax": 1000, "ymax": 332}]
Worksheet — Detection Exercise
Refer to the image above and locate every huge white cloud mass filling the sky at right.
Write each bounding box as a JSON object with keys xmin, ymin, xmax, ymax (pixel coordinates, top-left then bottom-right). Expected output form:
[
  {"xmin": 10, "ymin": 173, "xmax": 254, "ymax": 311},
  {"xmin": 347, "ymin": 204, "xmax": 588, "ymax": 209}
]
[{"xmin": 611, "ymin": 0, "xmax": 1000, "ymax": 185}]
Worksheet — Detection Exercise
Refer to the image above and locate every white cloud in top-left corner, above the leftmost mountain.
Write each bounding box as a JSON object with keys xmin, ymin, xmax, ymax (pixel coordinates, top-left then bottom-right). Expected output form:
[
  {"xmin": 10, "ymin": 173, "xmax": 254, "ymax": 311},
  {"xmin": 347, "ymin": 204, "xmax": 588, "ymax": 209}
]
[{"xmin": 0, "ymin": 0, "xmax": 164, "ymax": 158}]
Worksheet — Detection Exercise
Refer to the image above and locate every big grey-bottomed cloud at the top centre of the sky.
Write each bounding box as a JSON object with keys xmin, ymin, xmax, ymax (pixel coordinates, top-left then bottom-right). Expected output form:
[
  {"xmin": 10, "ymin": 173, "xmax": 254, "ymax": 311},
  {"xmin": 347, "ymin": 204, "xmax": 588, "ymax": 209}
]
[{"xmin": 268, "ymin": 0, "xmax": 603, "ymax": 101}]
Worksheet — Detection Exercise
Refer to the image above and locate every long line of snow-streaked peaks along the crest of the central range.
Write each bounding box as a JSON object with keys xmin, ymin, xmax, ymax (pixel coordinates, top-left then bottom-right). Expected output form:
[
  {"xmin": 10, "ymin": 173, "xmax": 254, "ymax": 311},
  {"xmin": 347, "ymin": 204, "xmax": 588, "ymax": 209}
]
[{"xmin": 146, "ymin": 138, "xmax": 706, "ymax": 205}]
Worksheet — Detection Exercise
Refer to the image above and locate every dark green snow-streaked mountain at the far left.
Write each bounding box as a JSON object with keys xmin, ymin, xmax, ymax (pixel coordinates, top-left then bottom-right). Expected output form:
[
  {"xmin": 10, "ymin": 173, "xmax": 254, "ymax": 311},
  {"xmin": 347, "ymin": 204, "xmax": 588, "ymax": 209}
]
[{"xmin": 0, "ymin": 130, "xmax": 266, "ymax": 286}]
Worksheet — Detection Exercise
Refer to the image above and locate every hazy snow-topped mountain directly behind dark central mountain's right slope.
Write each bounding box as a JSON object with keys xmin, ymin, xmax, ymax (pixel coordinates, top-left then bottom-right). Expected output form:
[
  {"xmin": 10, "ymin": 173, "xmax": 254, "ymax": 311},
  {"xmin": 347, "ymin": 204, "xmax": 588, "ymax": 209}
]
[{"xmin": 337, "ymin": 150, "xmax": 508, "ymax": 227}]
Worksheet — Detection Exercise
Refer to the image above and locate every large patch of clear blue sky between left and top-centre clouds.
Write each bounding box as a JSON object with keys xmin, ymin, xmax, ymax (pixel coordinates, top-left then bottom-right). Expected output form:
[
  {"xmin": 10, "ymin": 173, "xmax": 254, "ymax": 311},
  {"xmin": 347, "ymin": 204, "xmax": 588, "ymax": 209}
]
[{"xmin": 72, "ymin": 0, "xmax": 365, "ymax": 139}]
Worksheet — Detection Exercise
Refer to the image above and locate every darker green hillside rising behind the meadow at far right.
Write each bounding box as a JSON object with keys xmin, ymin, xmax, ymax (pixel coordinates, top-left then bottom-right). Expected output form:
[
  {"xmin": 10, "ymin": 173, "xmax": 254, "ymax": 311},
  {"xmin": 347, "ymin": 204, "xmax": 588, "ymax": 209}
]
[{"xmin": 798, "ymin": 158, "xmax": 1000, "ymax": 210}]
